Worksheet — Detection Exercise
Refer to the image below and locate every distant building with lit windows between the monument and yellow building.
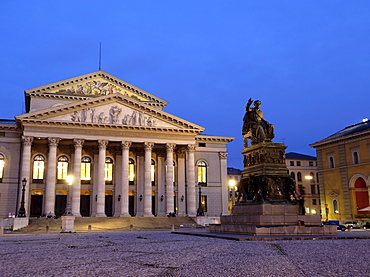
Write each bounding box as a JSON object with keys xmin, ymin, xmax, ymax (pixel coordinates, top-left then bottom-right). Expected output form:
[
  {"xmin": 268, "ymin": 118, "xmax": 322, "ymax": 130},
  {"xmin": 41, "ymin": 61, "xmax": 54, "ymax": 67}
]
[{"xmin": 285, "ymin": 152, "xmax": 321, "ymax": 215}]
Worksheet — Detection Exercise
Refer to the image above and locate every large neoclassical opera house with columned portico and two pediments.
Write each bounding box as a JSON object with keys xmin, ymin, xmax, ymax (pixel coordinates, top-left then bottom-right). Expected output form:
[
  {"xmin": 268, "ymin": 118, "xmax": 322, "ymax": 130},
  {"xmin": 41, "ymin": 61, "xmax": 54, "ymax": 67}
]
[{"xmin": 0, "ymin": 71, "xmax": 233, "ymax": 217}]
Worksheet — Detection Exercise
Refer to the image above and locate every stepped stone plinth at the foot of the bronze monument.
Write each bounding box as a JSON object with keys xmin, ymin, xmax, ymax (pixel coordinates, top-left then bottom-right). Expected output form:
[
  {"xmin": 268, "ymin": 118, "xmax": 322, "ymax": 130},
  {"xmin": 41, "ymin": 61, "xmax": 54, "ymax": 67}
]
[{"xmin": 209, "ymin": 204, "xmax": 337, "ymax": 235}]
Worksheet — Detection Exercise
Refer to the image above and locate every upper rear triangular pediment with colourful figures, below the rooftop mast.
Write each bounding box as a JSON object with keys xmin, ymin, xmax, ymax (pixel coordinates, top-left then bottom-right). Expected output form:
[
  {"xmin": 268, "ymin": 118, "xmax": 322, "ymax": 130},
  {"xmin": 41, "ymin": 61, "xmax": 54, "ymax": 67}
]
[{"xmin": 25, "ymin": 71, "xmax": 168, "ymax": 108}]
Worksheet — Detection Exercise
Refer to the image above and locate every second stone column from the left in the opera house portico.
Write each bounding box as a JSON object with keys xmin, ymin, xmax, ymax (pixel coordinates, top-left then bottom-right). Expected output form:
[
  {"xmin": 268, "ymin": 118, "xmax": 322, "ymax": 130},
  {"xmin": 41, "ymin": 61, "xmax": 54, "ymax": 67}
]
[{"xmin": 44, "ymin": 138, "xmax": 59, "ymax": 215}]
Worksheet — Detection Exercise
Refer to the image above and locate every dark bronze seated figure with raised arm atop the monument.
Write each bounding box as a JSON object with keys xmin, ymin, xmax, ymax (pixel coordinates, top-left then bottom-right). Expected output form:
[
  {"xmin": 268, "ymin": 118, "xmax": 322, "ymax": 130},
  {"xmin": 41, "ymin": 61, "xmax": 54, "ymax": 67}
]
[{"xmin": 242, "ymin": 98, "xmax": 275, "ymax": 145}]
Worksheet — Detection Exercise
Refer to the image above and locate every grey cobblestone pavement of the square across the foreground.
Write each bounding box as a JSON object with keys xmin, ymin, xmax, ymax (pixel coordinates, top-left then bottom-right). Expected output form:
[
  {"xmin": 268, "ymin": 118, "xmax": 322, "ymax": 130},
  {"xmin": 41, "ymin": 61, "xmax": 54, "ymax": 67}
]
[{"xmin": 0, "ymin": 231, "xmax": 370, "ymax": 277}]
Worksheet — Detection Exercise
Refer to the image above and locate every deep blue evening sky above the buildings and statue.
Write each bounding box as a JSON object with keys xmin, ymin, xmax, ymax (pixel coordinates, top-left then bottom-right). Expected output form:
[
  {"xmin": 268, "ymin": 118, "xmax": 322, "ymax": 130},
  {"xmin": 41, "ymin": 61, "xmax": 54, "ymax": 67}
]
[{"xmin": 0, "ymin": 0, "xmax": 370, "ymax": 169}]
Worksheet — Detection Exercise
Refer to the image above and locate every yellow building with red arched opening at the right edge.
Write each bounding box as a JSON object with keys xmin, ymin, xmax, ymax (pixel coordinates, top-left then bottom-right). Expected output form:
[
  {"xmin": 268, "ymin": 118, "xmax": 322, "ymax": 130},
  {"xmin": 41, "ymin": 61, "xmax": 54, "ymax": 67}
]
[{"xmin": 311, "ymin": 119, "xmax": 370, "ymax": 222}]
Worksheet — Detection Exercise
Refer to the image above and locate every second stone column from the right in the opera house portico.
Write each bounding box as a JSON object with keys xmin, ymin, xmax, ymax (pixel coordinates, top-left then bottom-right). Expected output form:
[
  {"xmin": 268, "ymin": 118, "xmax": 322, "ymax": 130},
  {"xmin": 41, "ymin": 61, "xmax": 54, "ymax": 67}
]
[{"xmin": 166, "ymin": 143, "xmax": 176, "ymax": 214}]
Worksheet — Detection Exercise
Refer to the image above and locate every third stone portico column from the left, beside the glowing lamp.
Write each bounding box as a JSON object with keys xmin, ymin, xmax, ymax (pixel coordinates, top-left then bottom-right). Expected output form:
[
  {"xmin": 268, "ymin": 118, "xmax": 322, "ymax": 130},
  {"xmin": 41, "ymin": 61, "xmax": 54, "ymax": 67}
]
[{"xmin": 72, "ymin": 139, "xmax": 84, "ymax": 217}]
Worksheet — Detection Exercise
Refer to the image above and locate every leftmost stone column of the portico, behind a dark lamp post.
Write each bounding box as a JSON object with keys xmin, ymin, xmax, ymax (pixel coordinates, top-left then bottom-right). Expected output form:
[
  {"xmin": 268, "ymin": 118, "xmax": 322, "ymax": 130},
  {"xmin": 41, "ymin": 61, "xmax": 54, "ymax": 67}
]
[{"xmin": 17, "ymin": 136, "xmax": 33, "ymax": 217}]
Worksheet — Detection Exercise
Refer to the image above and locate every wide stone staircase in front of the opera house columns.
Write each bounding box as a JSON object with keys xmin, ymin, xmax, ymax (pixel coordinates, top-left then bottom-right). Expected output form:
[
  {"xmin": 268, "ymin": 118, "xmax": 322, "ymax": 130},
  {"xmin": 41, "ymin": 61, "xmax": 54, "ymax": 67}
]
[{"xmin": 20, "ymin": 217, "xmax": 197, "ymax": 232}]
